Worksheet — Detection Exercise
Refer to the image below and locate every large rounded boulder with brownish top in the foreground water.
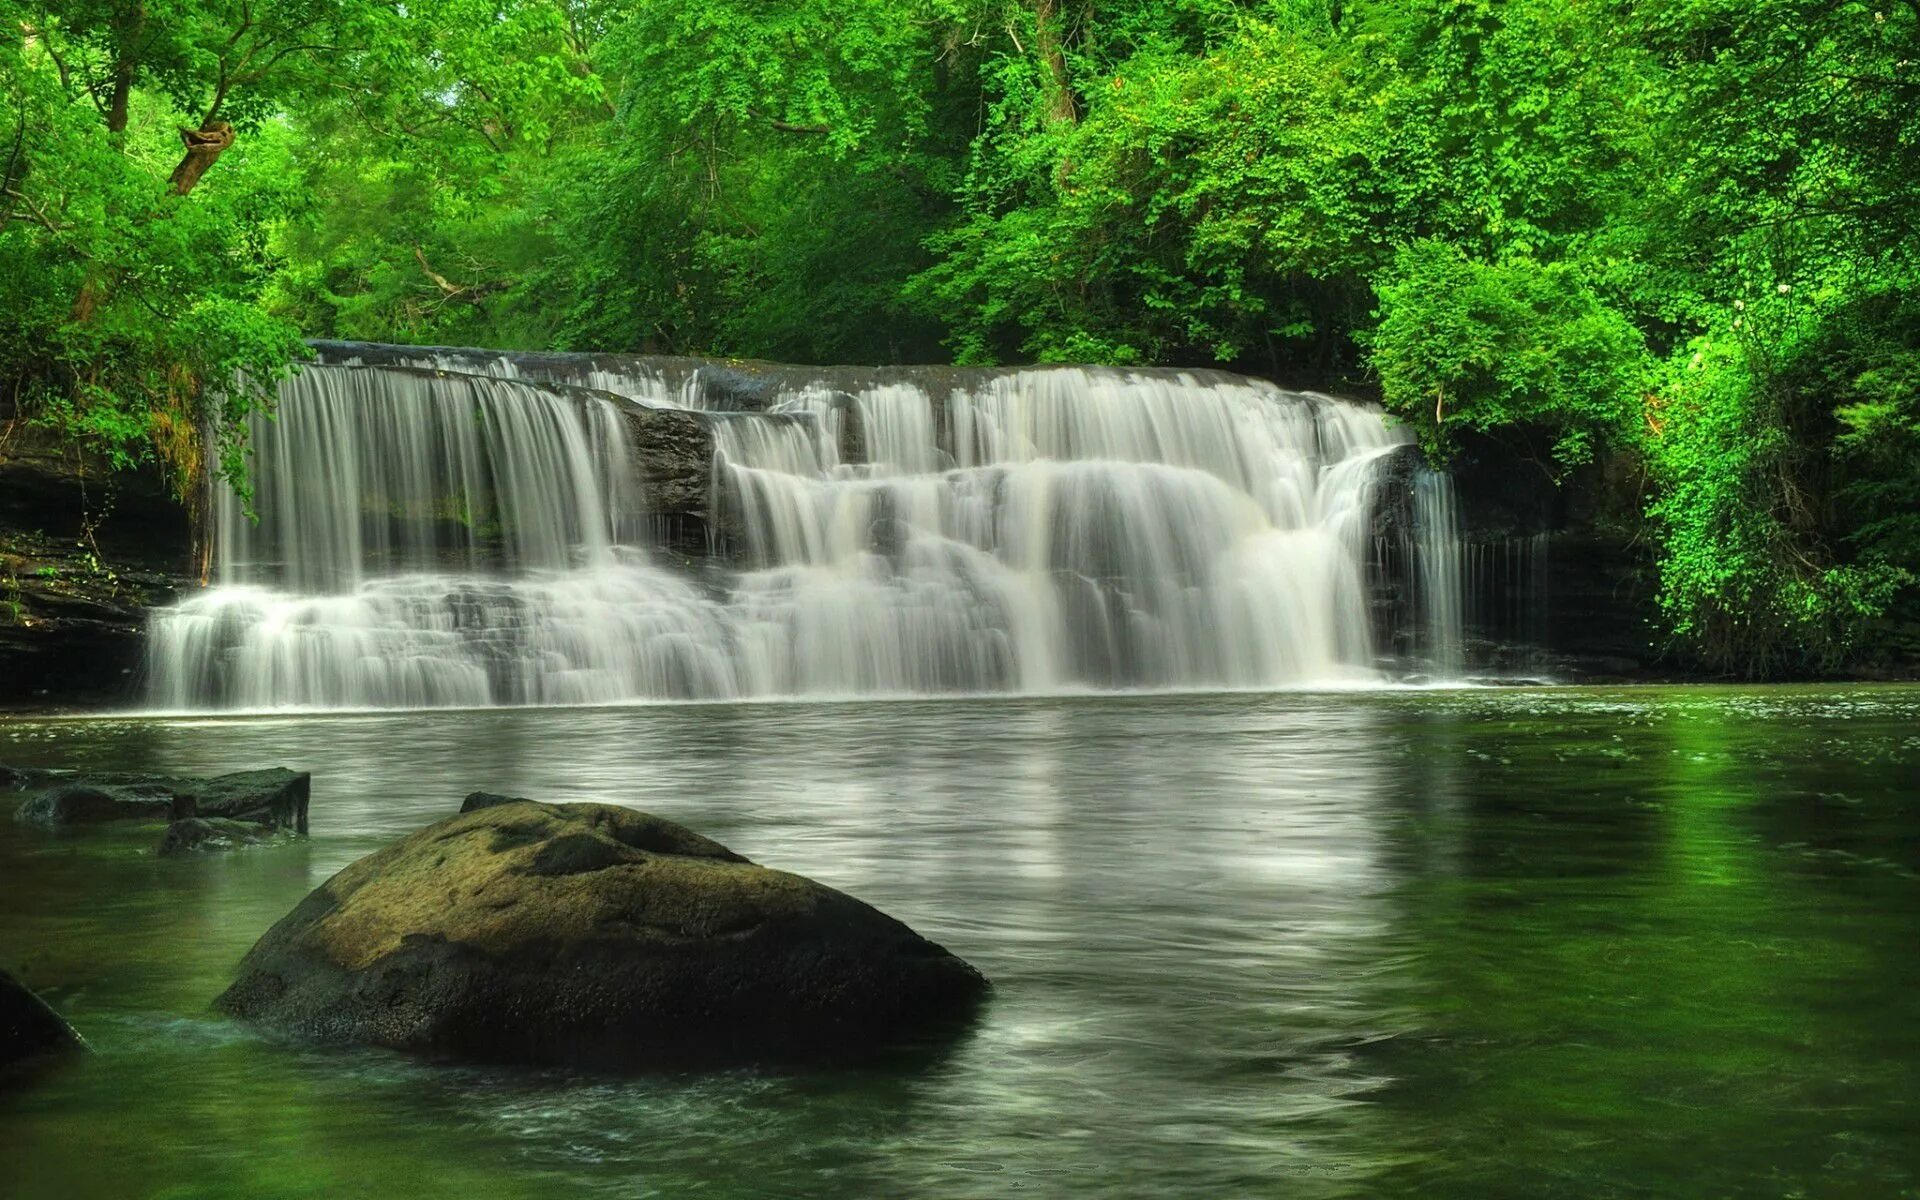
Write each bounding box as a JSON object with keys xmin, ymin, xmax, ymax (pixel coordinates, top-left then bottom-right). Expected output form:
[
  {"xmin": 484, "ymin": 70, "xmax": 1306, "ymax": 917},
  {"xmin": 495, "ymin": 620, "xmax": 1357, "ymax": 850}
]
[{"xmin": 217, "ymin": 801, "xmax": 987, "ymax": 1068}]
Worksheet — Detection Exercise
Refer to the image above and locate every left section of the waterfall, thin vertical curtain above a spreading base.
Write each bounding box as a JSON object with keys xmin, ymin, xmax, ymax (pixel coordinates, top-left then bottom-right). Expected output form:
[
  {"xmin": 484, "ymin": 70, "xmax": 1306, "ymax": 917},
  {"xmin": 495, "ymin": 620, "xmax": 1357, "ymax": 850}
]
[{"xmin": 148, "ymin": 367, "xmax": 733, "ymax": 708}]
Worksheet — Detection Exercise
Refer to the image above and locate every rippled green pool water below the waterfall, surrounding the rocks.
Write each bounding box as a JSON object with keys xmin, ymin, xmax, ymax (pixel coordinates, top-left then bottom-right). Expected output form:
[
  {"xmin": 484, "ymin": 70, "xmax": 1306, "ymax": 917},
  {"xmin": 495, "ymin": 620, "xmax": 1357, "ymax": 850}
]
[{"xmin": 0, "ymin": 687, "xmax": 1920, "ymax": 1200}]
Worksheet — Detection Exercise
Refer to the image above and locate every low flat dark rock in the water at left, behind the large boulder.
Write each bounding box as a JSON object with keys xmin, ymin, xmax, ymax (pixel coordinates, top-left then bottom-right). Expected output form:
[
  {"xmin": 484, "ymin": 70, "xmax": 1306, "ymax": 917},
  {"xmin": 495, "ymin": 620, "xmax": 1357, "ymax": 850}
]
[{"xmin": 0, "ymin": 768, "xmax": 313, "ymax": 833}]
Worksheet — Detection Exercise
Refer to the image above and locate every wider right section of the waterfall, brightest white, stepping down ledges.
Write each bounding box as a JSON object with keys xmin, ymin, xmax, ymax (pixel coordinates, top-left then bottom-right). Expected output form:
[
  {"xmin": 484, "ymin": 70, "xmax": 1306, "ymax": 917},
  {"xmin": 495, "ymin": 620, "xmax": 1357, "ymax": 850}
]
[{"xmin": 720, "ymin": 369, "xmax": 1398, "ymax": 693}]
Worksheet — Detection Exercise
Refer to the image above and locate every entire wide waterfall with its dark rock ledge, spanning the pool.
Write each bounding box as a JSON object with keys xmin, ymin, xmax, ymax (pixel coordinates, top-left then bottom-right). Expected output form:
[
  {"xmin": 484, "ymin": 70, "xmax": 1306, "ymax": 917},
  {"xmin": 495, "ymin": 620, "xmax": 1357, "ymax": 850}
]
[{"xmin": 146, "ymin": 344, "xmax": 1463, "ymax": 710}]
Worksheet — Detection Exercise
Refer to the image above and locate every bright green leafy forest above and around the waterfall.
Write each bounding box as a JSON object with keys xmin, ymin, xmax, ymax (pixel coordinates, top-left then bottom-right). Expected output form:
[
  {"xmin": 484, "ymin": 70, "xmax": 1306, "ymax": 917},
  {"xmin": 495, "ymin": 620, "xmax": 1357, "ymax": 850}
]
[{"xmin": 0, "ymin": 0, "xmax": 1920, "ymax": 676}]
